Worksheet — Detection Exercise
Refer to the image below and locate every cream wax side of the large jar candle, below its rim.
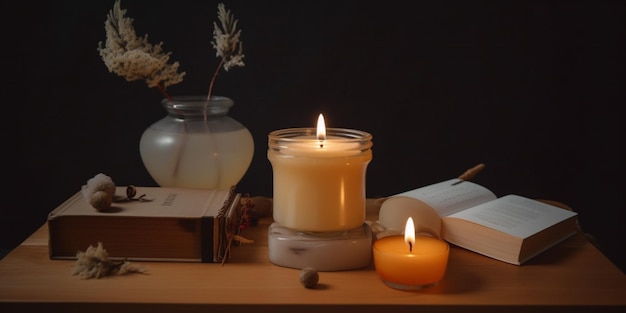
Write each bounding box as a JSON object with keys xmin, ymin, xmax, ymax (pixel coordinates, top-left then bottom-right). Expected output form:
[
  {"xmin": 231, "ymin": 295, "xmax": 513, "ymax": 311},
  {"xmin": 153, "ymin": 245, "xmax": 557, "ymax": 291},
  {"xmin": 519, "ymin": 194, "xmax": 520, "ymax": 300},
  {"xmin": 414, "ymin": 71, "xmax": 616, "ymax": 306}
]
[{"xmin": 268, "ymin": 151, "xmax": 371, "ymax": 232}]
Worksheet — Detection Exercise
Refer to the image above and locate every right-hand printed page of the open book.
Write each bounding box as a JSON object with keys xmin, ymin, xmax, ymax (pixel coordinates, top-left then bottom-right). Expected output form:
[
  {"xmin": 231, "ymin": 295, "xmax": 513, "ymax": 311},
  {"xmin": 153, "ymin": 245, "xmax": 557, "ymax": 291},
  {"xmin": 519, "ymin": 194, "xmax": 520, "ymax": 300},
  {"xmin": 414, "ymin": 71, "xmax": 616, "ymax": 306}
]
[{"xmin": 449, "ymin": 195, "xmax": 576, "ymax": 238}]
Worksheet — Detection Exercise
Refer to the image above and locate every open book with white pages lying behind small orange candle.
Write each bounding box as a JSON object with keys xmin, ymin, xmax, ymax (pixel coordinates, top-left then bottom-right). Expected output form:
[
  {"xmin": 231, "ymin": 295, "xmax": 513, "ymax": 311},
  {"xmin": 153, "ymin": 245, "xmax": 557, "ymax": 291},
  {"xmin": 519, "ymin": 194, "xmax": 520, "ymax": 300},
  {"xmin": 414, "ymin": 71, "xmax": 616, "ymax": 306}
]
[{"xmin": 396, "ymin": 179, "xmax": 577, "ymax": 265}]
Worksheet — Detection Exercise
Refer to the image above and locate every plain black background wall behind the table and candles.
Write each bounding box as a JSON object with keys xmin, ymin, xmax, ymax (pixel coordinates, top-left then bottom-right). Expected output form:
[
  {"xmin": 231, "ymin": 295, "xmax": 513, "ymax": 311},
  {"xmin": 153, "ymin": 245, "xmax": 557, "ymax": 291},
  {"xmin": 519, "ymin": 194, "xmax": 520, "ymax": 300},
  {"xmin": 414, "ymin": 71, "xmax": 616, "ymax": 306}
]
[{"xmin": 0, "ymin": 0, "xmax": 626, "ymax": 271}]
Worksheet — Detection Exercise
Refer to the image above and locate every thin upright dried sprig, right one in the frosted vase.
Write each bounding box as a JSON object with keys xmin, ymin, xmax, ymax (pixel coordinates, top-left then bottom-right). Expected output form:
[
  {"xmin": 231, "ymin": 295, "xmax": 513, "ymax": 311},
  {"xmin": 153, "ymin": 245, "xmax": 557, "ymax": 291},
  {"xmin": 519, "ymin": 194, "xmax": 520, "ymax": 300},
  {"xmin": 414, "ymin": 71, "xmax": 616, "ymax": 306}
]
[{"xmin": 207, "ymin": 3, "xmax": 245, "ymax": 100}]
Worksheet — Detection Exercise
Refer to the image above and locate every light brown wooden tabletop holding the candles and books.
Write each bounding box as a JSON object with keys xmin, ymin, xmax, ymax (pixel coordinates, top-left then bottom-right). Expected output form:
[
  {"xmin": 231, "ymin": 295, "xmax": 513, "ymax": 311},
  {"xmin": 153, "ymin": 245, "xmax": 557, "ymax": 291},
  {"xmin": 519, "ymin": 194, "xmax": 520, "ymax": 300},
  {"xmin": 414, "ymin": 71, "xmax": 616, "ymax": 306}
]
[{"xmin": 0, "ymin": 199, "xmax": 626, "ymax": 313}]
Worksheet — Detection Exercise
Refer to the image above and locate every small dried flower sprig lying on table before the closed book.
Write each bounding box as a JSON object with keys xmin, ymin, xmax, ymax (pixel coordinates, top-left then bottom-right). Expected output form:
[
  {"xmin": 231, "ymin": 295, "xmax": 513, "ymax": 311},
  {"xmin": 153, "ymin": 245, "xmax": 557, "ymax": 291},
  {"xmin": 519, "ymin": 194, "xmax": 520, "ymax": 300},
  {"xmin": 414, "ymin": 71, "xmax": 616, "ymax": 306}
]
[{"xmin": 72, "ymin": 242, "xmax": 147, "ymax": 279}]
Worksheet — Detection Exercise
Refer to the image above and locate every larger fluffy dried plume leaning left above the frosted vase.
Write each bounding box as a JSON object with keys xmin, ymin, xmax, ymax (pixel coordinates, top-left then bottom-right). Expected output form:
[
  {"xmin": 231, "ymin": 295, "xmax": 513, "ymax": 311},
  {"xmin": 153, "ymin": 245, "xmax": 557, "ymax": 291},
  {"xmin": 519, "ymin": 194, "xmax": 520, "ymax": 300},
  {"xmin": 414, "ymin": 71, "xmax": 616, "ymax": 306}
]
[{"xmin": 98, "ymin": 0, "xmax": 186, "ymax": 98}]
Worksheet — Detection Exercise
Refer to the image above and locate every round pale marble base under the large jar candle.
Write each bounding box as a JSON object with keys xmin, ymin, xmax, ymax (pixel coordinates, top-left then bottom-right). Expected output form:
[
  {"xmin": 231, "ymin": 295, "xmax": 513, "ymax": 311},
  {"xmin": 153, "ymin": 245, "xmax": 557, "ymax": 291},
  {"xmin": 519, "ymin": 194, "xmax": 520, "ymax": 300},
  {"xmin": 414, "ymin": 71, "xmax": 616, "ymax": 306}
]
[{"xmin": 268, "ymin": 222, "xmax": 372, "ymax": 272}]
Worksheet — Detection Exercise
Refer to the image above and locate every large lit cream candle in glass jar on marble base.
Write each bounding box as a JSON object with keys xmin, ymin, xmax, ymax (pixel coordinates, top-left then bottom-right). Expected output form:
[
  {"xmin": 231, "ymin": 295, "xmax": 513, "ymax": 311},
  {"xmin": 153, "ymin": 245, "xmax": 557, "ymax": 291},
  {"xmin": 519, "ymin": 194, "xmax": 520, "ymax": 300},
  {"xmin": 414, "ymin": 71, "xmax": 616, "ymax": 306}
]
[{"xmin": 267, "ymin": 114, "xmax": 372, "ymax": 232}]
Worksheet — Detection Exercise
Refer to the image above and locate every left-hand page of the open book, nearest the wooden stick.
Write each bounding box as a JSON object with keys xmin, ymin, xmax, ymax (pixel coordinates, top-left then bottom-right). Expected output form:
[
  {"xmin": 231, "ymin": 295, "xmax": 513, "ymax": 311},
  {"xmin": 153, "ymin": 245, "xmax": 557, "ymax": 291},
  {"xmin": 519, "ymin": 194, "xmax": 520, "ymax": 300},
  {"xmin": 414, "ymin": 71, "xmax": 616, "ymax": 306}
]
[{"xmin": 397, "ymin": 178, "xmax": 497, "ymax": 217}]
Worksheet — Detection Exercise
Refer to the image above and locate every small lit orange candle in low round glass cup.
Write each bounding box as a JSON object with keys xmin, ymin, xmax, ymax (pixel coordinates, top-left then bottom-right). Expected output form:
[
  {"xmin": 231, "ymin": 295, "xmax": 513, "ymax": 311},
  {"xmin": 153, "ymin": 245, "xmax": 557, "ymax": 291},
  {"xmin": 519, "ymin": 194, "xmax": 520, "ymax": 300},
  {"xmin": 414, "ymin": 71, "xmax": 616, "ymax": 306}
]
[{"xmin": 373, "ymin": 217, "xmax": 450, "ymax": 289}]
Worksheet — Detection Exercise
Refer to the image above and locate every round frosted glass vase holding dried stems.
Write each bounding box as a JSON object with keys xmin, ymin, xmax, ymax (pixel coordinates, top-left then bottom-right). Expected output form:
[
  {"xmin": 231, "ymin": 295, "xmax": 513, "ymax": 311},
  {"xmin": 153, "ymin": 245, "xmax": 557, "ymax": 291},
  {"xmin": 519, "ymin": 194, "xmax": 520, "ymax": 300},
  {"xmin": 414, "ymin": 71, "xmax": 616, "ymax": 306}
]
[{"xmin": 139, "ymin": 96, "xmax": 254, "ymax": 189}]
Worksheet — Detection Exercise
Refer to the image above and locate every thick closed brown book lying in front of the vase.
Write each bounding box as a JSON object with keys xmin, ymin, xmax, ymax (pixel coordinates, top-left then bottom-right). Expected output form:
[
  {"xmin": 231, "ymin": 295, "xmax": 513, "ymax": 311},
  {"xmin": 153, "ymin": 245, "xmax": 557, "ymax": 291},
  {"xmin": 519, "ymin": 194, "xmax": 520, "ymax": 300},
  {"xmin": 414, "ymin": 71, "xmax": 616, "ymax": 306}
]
[{"xmin": 47, "ymin": 186, "xmax": 240, "ymax": 263}]
